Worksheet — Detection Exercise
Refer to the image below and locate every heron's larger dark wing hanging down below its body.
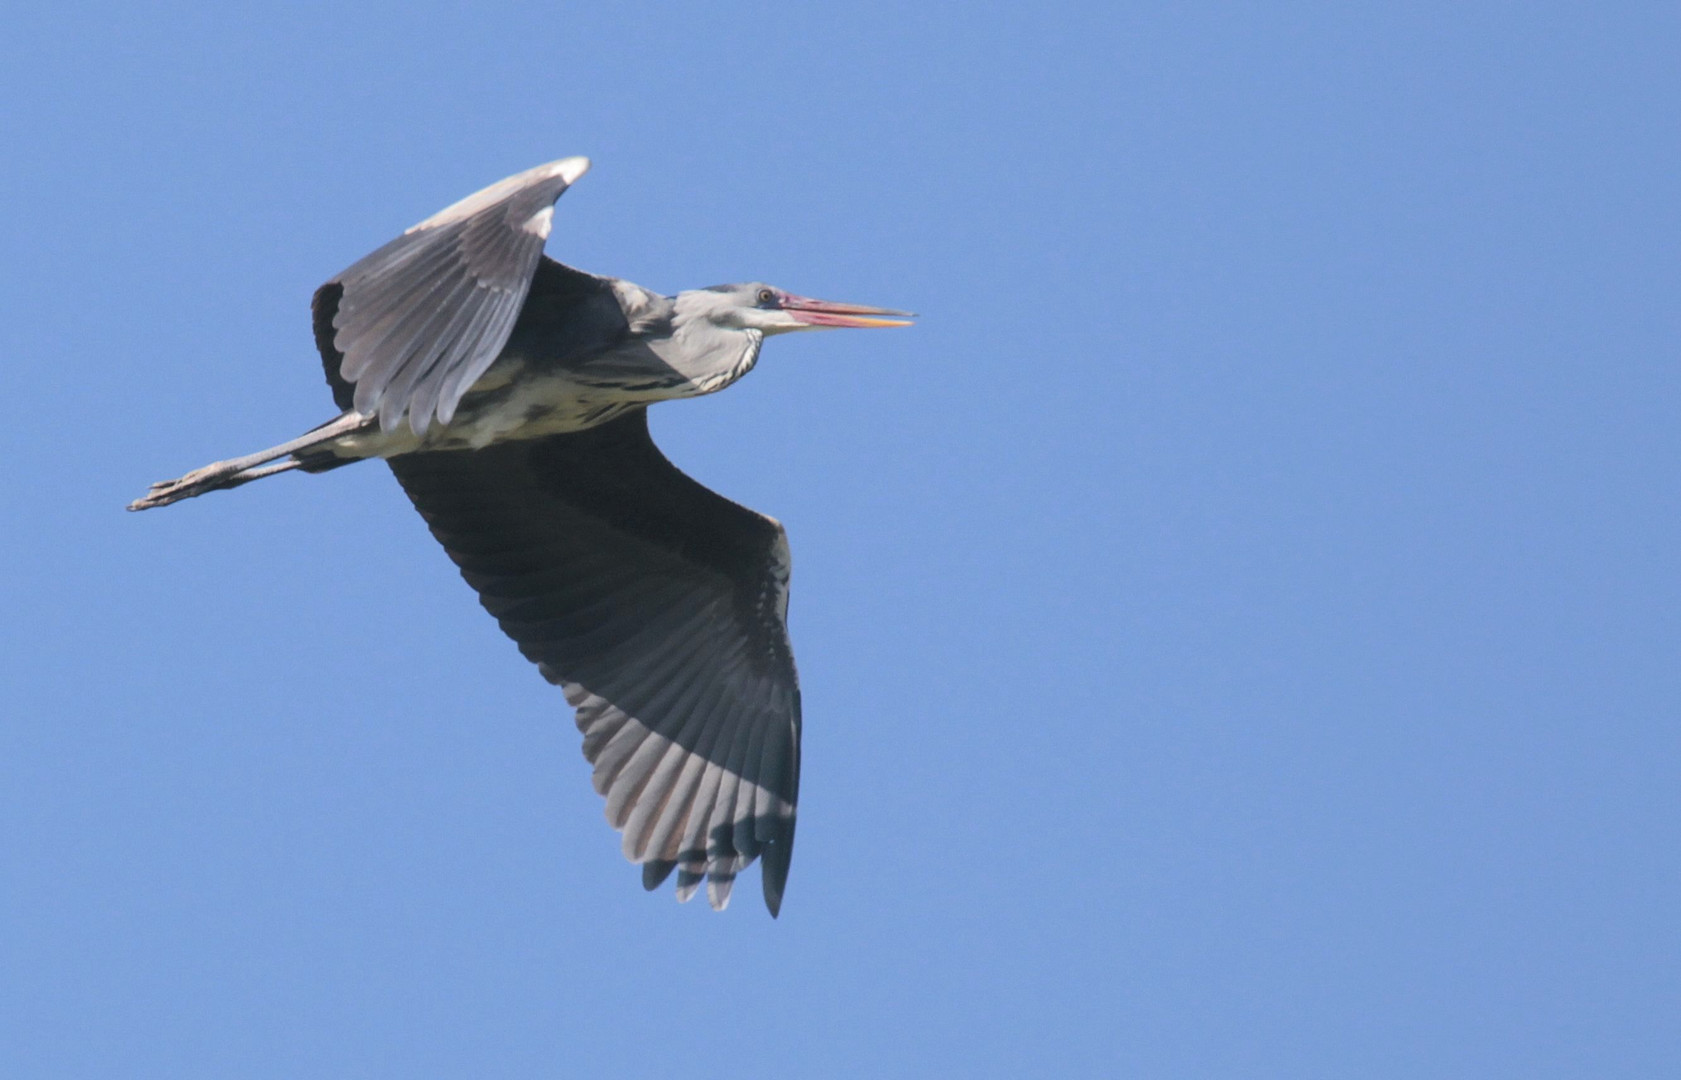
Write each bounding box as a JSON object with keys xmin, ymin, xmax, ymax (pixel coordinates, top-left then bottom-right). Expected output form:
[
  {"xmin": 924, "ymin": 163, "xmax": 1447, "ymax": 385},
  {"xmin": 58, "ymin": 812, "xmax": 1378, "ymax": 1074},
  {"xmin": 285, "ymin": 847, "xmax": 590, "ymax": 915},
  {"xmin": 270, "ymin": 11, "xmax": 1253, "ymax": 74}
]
[{"xmin": 390, "ymin": 409, "xmax": 800, "ymax": 915}]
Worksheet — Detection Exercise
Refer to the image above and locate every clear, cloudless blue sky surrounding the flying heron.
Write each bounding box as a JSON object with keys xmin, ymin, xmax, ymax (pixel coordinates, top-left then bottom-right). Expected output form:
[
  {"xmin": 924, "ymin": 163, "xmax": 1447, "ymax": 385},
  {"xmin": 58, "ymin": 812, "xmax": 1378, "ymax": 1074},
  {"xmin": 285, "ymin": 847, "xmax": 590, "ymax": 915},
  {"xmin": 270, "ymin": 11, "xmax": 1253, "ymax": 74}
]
[{"xmin": 0, "ymin": 0, "xmax": 1681, "ymax": 1080}]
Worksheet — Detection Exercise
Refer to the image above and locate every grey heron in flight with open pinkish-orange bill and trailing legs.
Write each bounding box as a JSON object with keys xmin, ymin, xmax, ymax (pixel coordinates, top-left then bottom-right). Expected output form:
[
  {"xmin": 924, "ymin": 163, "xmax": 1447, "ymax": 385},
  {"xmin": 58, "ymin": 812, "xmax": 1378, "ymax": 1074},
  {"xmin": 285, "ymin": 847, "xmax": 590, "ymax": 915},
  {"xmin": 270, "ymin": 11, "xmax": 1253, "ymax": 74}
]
[{"xmin": 129, "ymin": 158, "xmax": 911, "ymax": 915}]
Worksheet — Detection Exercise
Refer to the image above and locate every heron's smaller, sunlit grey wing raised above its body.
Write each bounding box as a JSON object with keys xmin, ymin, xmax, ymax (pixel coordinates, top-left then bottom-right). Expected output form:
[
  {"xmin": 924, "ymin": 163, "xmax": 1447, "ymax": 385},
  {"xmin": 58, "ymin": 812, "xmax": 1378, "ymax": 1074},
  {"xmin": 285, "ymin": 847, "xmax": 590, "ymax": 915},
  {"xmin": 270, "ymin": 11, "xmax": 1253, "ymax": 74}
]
[{"xmin": 316, "ymin": 158, "xmax": 590, "ymax": 434}]
